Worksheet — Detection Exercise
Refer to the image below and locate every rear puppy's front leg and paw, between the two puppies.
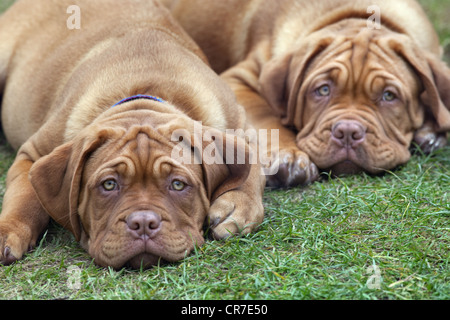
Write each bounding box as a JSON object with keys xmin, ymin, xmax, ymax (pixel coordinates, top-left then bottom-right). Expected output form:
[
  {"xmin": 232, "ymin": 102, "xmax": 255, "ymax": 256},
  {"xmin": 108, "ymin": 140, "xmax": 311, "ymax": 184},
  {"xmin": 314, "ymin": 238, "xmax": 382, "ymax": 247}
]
[{"xmin": 222, "ymin": 62, "xmax": 319, "ymax": 187}]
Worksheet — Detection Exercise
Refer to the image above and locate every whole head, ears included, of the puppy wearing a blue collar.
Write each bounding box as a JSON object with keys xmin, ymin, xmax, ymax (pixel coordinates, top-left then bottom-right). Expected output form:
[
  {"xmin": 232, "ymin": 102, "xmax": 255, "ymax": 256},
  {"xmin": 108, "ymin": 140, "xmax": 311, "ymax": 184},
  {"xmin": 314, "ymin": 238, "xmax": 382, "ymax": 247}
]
[{"xmin": 30, "ymin": 117, "xmax": 250, "ymax": 268}]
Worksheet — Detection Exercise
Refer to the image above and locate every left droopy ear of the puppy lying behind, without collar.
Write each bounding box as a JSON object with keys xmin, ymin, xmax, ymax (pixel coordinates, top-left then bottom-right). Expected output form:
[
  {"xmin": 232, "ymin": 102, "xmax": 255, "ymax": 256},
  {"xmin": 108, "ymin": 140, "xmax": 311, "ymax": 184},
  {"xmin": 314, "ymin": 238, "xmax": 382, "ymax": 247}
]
[{"xmin": 259, "ymin": 34, "xmax": 334, "ymax": 129}]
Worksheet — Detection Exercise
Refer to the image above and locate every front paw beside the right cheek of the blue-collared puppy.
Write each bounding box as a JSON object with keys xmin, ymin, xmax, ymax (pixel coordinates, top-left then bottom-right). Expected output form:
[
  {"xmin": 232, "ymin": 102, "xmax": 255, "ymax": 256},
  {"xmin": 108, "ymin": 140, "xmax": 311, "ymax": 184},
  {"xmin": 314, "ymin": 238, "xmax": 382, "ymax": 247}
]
[{"xmin": 208, "ymin": 190, "xmax": 264, "ymax": 240}]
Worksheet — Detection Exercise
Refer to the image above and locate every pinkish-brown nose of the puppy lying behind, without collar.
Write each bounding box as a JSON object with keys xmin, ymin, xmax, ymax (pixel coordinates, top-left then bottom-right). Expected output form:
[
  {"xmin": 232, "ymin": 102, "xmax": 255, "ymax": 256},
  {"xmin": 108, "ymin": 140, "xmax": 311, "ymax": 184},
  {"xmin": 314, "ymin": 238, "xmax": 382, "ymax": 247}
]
[{"xmin": 331, "ymin": 120, "xmax": 366, "ymax": 148}]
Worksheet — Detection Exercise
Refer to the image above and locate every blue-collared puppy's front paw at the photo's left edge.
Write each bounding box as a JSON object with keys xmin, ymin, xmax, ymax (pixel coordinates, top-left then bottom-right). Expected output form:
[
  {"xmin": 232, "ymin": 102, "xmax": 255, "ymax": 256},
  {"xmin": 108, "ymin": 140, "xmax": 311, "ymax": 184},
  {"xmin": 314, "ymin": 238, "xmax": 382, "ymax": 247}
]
[{"xmin": 0, "ymin": 223, "xmax": 34, "ymax": 265}]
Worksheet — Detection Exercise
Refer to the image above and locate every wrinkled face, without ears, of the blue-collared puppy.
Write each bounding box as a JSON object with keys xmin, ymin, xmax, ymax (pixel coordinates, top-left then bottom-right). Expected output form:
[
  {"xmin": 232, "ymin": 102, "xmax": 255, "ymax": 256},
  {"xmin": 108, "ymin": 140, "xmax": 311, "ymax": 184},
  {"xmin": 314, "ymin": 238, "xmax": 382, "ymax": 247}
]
[{"xmin": 78, "ymin": 131, "xmax": 207, "ymax": 268}]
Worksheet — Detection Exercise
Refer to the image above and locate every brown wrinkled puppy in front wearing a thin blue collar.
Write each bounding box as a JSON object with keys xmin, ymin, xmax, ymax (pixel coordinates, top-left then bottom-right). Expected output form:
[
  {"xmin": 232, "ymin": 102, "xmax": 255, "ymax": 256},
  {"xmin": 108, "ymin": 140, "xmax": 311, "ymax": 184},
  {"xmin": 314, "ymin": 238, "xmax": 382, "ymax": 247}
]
[{"xmin": 0, "ymin": 0, "xmax": 265, "ymax": 268}]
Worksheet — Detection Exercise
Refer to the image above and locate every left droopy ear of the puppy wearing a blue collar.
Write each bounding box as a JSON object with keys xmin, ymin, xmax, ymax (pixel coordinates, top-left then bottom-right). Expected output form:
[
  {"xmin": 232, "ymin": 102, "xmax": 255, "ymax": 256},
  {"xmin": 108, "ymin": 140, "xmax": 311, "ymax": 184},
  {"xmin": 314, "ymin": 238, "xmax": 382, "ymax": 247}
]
[{"xmin": 29, "ymin": 130, "xmax": 112, "ymax": 241}]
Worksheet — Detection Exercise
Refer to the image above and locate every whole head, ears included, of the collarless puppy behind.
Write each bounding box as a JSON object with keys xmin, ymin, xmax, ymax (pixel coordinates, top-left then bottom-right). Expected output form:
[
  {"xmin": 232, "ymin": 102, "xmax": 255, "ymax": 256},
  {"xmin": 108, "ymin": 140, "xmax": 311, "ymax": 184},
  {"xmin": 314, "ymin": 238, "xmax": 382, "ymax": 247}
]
[{"xmin": 260, "ymin": 21, "xmax": 450, "ymax": 174}]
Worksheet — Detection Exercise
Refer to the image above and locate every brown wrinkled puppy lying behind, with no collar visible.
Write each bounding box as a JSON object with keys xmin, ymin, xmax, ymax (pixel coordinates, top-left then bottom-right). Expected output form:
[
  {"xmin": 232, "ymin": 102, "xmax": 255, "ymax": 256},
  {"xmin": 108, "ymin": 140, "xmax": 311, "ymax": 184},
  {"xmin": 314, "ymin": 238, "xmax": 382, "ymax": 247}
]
[{"xmin": 164, "ymin": 0, "xmax": 450, "ymax": 186}]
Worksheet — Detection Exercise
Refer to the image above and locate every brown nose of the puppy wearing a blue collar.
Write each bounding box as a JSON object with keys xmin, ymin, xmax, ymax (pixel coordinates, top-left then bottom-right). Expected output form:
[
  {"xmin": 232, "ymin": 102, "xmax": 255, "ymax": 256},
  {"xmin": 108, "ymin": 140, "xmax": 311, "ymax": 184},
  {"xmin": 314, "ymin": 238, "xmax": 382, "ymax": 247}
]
[{"xmin": 126, "ymin": 211, "xmax": 161, "ymax": 238}]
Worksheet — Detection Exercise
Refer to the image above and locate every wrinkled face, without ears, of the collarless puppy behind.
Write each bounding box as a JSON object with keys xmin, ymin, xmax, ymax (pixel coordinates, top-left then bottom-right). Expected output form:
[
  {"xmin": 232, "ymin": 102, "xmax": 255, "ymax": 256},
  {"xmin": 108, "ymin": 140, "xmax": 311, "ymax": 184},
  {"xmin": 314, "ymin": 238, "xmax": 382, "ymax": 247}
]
[{"xmin": 297, "ymin": 34, "xmax": 423, "ymax": 174}]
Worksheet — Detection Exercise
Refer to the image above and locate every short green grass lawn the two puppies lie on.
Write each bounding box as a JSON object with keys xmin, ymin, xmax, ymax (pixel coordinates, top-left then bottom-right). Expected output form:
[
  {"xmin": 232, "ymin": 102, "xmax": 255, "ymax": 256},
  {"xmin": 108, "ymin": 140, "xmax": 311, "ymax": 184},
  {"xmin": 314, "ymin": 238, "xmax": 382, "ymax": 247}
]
[{"xmin": 0, "ymin": 0, "xmax": 450, "ymax": 300}]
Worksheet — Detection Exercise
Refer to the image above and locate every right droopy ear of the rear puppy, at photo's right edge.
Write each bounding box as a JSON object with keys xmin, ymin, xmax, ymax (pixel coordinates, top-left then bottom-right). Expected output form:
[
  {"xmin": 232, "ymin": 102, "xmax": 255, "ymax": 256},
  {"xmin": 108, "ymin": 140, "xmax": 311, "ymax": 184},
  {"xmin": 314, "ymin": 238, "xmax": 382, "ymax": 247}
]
[{"xmin": 390, "ymin": 39, "xmax": 450, "ymax": 132}]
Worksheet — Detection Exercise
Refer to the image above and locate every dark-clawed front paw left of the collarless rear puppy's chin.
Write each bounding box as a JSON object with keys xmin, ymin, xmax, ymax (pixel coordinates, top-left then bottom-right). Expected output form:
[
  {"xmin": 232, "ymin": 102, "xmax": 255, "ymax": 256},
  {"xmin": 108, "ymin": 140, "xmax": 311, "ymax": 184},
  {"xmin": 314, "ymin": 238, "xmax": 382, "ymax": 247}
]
[{"xmin": 266, "ymin": 148, "xmax": 319, "ymax": 188}]
